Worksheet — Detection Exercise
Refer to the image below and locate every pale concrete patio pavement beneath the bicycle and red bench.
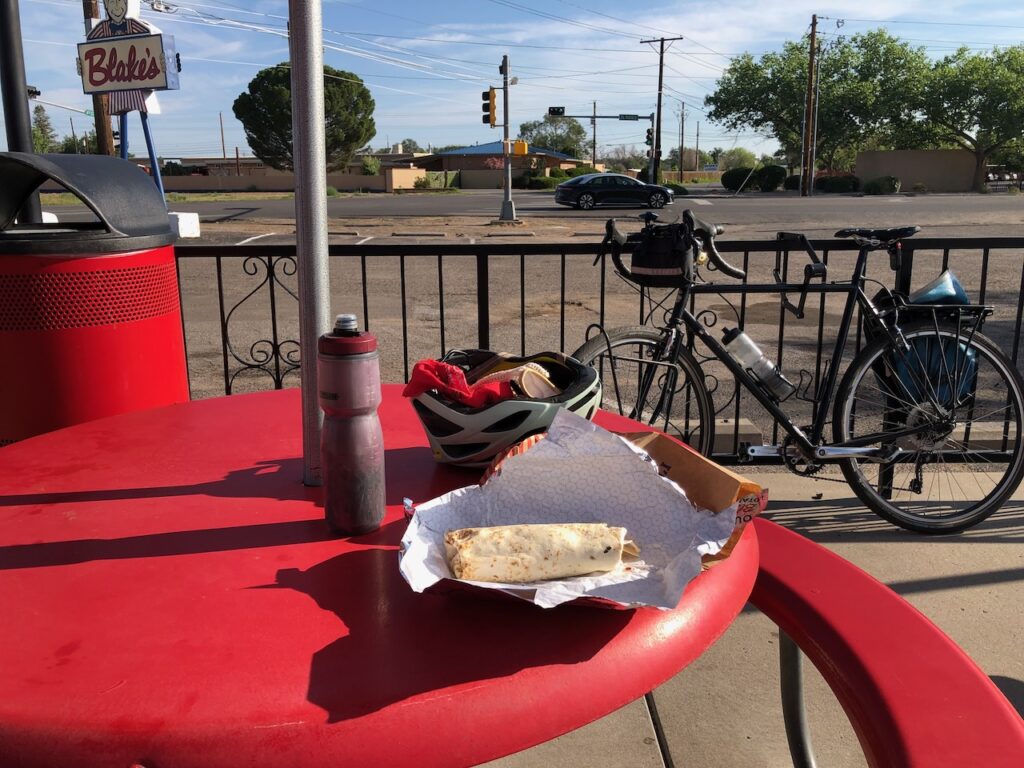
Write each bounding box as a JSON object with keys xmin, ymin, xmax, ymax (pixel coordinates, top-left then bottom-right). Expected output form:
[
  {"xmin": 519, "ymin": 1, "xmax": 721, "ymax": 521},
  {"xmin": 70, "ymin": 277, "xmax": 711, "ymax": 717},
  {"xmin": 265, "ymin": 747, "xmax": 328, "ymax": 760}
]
[{"xmin": 487, "ymin": 467, "xmax": 1024, "ymax": 768}]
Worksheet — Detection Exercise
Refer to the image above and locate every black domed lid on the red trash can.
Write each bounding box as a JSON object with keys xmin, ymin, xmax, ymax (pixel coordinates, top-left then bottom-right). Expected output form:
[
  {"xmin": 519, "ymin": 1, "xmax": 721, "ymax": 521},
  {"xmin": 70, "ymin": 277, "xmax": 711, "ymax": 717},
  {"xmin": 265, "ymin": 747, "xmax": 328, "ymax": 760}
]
[{"xmin": 0, "ymin": 152, "xmax": 174, "ymax": 256}]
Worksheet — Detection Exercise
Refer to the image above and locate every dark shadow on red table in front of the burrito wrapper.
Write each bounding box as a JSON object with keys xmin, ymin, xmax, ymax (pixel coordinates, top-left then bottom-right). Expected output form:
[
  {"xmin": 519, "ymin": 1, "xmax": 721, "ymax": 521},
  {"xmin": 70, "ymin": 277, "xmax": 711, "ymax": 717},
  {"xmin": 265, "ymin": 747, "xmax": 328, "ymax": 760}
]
[{"xmin": 276, "ymin": 544, "xmax": 633, "ymax": 723}]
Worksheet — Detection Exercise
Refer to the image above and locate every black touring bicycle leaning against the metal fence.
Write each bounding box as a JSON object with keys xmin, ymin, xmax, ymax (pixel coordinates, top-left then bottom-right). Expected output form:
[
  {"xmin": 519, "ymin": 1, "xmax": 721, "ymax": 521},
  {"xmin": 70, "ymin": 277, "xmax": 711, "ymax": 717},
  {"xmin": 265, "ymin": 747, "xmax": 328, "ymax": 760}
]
[{"xmin": 572, "ymin": 210, "xmax": 1024, "ymax": 534}]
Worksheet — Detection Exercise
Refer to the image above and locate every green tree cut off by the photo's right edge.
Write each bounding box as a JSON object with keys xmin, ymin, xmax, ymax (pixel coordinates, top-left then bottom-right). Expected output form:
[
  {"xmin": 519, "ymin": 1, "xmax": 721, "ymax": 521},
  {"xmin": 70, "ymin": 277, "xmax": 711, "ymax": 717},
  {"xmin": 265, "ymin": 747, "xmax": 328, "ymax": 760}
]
[{"xmin": 920, "ymin": 45, "xmax": 1024, "ymax": 190}]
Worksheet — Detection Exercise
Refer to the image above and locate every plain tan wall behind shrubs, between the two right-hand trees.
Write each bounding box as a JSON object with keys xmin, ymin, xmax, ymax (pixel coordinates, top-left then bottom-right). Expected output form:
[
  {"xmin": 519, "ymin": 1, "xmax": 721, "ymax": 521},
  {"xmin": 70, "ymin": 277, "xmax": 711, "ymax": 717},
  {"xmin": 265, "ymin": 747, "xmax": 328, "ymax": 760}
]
[{"xmin": 856, "ymin": 150, "xmax": 974, "ymax": 193}]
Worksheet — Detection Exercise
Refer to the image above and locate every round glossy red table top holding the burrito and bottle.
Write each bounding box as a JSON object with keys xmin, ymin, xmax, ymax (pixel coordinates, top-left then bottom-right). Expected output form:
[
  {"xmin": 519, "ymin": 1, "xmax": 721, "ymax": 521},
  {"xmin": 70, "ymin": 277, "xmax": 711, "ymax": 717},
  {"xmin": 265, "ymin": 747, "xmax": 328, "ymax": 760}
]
[{"xmin": 0, "ymin": 386, "xmax": 758, "ymax": 768}]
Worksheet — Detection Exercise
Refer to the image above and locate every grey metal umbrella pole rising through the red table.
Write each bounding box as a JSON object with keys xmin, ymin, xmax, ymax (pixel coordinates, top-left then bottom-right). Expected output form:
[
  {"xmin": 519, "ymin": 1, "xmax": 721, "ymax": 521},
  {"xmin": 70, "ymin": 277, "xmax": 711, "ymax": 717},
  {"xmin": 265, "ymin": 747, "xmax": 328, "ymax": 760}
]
[{"xmin": 288, "ymin": 0, "xmax": 331, "ymax": 485}]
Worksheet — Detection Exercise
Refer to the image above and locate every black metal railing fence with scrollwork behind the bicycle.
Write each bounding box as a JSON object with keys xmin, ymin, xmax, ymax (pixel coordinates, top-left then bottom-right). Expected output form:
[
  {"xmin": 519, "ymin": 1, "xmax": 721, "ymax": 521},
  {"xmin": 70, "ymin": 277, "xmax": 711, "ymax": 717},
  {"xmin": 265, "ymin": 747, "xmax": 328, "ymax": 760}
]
[{"xmin": 177, "ymin": 238, "xmax": 1024, "ymax": 457}]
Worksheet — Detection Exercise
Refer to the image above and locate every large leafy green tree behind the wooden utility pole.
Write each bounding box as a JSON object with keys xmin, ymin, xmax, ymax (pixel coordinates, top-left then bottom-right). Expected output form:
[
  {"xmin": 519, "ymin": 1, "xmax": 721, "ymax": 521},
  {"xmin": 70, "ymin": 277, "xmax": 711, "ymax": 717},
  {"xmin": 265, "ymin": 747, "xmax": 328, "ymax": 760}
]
[{"xmin": 705, "ymin": 30, "xmax": 929, "ymax": 167}]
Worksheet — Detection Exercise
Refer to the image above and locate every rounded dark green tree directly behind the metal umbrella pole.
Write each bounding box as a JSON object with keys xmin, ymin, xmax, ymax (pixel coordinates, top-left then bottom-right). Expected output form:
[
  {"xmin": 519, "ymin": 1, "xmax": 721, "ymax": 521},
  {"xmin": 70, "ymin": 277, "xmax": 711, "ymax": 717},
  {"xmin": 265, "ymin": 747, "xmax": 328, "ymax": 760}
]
[{"xmin": 233, "ymin": 63, "xmax": 377, "ymax": 171}]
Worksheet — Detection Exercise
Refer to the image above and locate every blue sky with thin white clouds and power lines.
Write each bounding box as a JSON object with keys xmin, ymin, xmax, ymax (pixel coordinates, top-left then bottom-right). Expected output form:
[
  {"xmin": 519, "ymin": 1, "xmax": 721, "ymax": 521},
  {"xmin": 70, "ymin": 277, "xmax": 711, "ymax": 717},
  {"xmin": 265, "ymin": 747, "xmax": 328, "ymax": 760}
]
[{"xmin": 0, "ymin": 0, "xmax": 1024, "ymax": 157}]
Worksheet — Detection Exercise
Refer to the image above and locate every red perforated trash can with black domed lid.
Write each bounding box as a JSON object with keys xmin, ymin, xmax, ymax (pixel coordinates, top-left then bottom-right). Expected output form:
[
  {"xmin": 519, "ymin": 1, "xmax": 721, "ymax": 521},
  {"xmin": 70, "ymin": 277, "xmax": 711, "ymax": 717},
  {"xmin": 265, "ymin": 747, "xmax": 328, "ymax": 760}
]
[{"xmin": 0, "ymin": 153, "xmax": 188, "ymax": 445}]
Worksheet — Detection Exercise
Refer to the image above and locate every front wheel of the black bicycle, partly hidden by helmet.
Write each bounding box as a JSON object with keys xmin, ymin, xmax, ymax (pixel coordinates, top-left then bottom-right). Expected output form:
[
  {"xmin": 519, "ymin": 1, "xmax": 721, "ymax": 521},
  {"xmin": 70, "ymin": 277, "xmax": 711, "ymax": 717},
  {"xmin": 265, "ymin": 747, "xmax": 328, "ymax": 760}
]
[{"xmin": 572, "ymin": 326, "xmax": 715, "ymax": 456}]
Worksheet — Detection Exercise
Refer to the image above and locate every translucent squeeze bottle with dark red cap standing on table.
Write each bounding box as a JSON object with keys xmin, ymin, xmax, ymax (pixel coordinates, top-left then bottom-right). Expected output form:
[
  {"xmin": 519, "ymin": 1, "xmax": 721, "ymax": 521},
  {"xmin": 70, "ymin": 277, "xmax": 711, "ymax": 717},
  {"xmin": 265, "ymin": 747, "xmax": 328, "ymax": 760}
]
[{"xmin": 316, "ymin": 314, "xmax": 385, "ymax": 536}]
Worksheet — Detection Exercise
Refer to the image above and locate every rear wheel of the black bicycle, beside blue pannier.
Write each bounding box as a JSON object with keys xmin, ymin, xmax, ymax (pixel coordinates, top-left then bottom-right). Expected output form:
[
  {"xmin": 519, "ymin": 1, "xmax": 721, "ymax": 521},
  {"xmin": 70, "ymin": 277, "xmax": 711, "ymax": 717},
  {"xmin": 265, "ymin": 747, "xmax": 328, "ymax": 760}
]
[{"xmin": 833, "ymin": 323, "xmax": 1024, "ymax": 534}]
